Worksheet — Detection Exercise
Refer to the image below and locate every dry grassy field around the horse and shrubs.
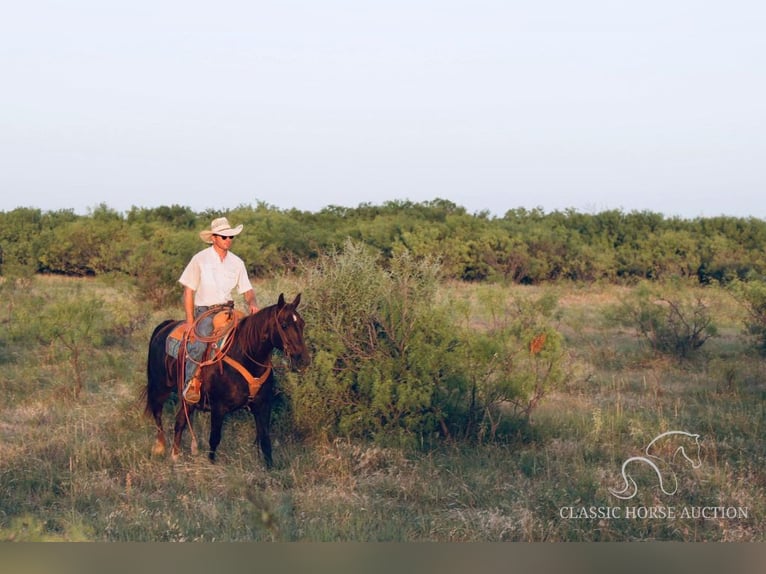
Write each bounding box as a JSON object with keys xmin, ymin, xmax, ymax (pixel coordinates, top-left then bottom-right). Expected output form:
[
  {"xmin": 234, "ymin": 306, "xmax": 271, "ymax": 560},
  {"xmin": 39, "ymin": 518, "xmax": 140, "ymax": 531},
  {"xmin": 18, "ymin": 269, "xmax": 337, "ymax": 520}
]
[{"xmin": 0, "ymin": 277, "xmax": 766, "ymax": 542}]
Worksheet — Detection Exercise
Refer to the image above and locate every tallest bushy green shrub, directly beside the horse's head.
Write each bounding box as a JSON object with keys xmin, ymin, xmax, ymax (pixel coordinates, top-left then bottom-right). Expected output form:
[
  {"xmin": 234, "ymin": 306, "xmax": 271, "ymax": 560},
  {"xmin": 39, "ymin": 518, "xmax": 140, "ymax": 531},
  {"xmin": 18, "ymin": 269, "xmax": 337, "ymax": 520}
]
[{"xmin": 291, "ymin": 241, "xmax": 446, "ymax": 441}]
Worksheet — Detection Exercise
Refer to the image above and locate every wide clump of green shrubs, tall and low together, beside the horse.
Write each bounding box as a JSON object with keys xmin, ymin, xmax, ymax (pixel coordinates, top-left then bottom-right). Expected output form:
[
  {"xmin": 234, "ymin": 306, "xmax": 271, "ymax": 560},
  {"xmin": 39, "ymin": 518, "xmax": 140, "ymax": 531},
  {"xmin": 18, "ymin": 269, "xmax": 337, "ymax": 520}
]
[{"xmin": 288, "ymin": 241, "xmax": 563, "ymax": 444}]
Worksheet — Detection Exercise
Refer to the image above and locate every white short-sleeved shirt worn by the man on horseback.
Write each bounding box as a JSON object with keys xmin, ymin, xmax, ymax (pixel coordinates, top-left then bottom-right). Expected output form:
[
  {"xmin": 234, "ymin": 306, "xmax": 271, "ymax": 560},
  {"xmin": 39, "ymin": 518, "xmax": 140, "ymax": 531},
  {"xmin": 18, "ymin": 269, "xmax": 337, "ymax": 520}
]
[{"xmin": 178, "ymin": 246, "xmax": 253, "ymax": 307}]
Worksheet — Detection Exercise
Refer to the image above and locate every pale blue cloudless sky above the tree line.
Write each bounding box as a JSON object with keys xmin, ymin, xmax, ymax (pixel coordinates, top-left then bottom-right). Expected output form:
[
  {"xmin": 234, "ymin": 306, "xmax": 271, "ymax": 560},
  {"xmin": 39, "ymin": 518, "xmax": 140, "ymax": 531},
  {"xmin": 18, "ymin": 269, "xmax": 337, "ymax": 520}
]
[{"xmin": 0, "ymin": 0, "xmax": 766, "ymax": 219}]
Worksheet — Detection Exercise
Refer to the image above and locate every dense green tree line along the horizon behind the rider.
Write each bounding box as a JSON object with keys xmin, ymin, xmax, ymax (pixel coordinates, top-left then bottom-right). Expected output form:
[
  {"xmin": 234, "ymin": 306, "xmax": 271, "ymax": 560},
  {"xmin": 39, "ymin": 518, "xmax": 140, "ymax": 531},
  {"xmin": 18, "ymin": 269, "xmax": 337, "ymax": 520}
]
[{"xmin": 0, "ymin": 199, "xmax": 766, "ymax": 296}]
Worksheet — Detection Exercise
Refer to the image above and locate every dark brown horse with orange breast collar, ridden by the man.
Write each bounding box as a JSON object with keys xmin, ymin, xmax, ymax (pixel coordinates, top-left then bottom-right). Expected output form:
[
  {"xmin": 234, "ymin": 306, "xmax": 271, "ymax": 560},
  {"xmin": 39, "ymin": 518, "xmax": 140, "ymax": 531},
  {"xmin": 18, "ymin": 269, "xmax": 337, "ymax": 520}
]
[{"xmin": 144, "ymin": 293, "xmax": 310, "ymax": 468}]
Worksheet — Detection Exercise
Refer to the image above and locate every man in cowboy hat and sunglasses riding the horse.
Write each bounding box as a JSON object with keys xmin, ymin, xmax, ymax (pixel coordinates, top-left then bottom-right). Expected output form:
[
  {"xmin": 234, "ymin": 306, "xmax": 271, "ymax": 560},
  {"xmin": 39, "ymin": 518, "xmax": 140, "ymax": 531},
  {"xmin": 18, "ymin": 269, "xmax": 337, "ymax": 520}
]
[{"xmin": 178, "ymin": 217, "xmax": 258, "ymax": 403}]
